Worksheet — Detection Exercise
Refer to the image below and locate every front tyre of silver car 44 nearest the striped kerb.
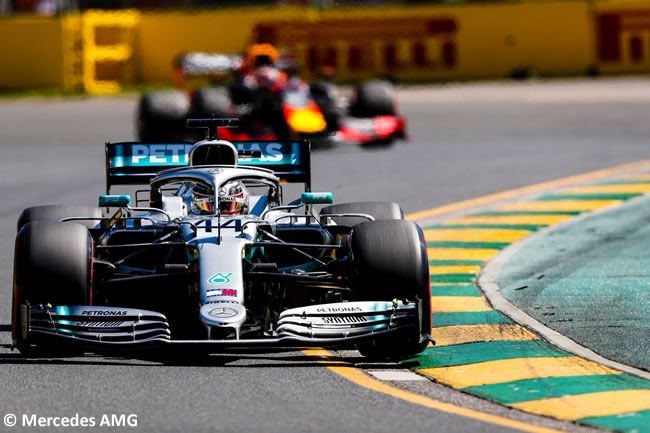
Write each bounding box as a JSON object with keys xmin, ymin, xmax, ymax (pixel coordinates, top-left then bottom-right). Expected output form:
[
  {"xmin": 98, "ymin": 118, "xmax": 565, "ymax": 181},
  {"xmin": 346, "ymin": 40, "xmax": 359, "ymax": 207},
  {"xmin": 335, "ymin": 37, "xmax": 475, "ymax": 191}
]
[{"xmin": 350, "ymin": 220, "xmax": 431, "ymax": 359}]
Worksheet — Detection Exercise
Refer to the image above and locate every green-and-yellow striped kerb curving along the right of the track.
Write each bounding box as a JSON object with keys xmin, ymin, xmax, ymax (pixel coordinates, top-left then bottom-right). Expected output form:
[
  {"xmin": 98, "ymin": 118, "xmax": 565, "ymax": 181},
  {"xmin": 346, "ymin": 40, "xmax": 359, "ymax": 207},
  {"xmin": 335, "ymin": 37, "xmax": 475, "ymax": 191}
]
[{"xmin": 402, "ymin": 166, "xmax": 650, "ymax": 431}]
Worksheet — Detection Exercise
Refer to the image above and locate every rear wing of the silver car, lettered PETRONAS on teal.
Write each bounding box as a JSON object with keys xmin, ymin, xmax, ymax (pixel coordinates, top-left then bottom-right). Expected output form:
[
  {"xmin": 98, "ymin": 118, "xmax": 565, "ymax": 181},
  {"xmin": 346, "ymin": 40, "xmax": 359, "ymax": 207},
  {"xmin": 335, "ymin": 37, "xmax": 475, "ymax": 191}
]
[{"xmin": 106, "ymin": 140, "xmax": 311, "ymax": 194}]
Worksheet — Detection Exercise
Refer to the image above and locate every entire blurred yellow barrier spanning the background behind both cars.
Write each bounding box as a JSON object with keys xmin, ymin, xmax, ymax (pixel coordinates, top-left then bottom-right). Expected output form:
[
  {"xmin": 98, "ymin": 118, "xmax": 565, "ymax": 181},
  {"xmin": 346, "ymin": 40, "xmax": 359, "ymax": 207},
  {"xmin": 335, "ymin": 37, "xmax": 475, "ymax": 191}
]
[{"xmin": 0, "ymin": 0, "xmax": 650, "ymax": 93}]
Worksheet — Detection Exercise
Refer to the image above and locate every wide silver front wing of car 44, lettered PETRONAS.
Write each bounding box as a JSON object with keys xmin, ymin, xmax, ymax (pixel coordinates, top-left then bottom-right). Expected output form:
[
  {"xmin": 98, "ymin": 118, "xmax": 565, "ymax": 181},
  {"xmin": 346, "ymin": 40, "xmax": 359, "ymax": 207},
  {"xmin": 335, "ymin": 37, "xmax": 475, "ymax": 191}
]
[{"xmin": 21, "ymin": 300, "xmax": 430, "ymax": 352}]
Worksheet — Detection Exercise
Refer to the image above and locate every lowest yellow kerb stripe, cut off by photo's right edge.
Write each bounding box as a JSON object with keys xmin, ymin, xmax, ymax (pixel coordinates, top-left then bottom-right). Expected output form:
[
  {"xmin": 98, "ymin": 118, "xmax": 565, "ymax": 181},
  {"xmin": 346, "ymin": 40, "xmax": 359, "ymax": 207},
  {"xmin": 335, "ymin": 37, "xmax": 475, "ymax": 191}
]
[{"xmin": 511, "ymin": 389, "xmax": 650, "ymax": 420}]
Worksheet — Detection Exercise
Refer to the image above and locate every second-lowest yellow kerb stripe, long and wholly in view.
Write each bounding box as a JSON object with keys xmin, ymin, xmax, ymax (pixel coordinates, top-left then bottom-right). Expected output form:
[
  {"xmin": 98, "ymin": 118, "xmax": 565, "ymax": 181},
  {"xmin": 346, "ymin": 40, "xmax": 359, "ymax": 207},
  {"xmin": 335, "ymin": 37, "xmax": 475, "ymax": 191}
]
[{"xmin": 418, "ymin": 356, "xmax": 620, "ymax": 388}]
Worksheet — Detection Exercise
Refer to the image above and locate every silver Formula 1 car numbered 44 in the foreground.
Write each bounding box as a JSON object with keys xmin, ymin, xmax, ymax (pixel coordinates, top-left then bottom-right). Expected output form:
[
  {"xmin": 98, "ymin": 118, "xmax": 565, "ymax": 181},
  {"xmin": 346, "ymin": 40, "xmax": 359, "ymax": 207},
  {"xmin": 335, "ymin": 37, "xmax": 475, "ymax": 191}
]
[{"xmin": 12, "ymin": 119, "xmax": 431, "ymax": 358}]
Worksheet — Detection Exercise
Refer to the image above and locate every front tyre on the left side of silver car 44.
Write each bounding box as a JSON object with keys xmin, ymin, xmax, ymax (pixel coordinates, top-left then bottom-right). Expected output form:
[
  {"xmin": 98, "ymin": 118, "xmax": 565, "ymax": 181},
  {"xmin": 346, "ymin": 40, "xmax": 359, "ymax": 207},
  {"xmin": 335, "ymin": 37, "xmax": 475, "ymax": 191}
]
[{"xmin": 12, "ymin": 221, "xmax": 93, "ymax": 353}]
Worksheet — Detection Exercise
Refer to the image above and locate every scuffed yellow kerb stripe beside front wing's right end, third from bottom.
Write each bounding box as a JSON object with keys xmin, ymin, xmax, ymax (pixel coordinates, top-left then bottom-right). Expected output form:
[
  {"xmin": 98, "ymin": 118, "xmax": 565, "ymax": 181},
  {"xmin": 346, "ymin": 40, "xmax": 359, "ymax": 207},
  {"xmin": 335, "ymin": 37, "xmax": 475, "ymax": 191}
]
[{"xmin": 431, "ymin": 323, "xmax": 539, "ymax": 347}]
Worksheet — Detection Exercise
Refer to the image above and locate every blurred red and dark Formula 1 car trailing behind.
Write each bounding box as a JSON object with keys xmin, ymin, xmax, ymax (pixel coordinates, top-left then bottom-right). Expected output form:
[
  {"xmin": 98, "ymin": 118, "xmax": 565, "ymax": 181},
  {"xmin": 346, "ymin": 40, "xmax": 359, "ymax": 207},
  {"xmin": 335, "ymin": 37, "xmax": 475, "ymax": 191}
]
[{"xmin": 136, "ymin": 44, "xmax": 406, "ymax": 146}]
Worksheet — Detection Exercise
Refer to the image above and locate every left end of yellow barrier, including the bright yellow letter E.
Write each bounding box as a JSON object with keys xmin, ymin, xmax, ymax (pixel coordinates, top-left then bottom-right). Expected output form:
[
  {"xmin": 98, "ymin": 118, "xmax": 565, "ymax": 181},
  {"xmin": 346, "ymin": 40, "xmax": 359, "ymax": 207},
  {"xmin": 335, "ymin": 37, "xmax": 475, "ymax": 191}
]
[{"xmin": 0, "ymin": 11, "xmax": 139, "ymax": 94}]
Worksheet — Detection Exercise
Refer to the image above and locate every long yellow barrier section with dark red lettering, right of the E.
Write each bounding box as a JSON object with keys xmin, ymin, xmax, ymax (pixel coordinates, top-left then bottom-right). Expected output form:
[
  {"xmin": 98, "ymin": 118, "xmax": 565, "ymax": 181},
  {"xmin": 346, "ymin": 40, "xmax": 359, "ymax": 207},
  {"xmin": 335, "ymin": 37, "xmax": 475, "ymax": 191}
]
[{"xmin": 136, "ymin": 1, "xmax": 593, "ymax": 82}]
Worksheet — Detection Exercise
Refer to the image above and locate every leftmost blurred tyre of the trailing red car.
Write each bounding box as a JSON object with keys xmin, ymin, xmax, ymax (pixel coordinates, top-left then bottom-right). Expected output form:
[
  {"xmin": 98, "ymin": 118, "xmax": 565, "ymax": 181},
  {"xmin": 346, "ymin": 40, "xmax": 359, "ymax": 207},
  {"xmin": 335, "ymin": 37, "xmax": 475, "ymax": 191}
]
[{"xmin": 136, "ymin": 91, "xmax": 190, "ymax": 142}]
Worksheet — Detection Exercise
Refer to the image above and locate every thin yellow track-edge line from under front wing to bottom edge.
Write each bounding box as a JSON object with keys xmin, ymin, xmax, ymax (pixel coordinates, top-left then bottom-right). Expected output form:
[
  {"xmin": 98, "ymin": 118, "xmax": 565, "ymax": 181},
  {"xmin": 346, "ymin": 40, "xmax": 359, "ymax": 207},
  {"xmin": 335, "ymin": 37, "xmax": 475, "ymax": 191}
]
[{"xmin": 303, "ymin": 349, "xmax": 560, "ymax": 433}]
